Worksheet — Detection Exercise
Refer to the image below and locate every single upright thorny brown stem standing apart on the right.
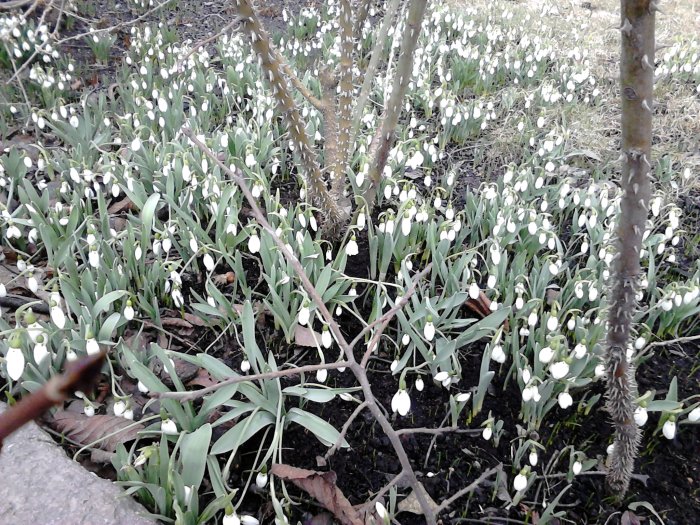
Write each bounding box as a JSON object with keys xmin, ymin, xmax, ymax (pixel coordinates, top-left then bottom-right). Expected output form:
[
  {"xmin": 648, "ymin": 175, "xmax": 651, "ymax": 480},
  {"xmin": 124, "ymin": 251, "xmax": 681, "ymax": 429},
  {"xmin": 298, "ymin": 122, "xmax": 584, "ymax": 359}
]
[{"xmin": 606, "ymin": 0, "xmax": 656, "ymax": 497}]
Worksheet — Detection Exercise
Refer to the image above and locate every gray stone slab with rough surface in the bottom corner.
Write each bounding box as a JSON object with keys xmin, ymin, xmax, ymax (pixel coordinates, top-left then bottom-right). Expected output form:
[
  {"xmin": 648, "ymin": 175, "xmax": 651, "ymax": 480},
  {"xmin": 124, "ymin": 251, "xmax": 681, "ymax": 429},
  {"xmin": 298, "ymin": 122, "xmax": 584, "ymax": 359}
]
[{"xmin": 0, "ymin": 403, "xmax": 157, "ymax": 525}]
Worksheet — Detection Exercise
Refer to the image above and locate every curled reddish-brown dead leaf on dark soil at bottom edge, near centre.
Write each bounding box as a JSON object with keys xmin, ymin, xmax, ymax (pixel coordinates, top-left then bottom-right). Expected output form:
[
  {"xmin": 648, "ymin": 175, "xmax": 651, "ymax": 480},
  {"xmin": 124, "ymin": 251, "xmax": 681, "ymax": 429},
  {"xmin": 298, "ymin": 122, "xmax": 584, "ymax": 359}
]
[{"xmin": 271, "ymin": 463, "xmax": 363, "ymax": 525}]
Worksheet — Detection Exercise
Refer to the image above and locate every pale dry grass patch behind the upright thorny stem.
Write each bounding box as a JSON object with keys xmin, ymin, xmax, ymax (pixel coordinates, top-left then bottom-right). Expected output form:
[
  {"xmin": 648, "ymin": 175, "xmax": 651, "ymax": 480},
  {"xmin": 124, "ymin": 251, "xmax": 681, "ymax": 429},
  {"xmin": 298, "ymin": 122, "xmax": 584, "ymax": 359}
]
[{"xmin": 451, "ymin": 0, "xmax": 700, "ymax": 184}]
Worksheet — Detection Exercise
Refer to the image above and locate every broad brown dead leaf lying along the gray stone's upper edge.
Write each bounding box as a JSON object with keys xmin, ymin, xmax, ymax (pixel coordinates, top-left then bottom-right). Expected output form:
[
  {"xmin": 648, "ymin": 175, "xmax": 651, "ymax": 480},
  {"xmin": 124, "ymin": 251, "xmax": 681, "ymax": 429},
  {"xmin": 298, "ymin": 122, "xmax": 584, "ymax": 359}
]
[{"xmin": 50, "ymin": 410, "xmax": 145, "ymax": 452}]
